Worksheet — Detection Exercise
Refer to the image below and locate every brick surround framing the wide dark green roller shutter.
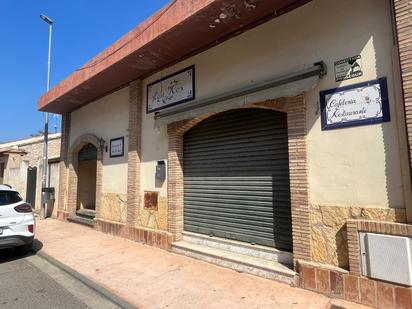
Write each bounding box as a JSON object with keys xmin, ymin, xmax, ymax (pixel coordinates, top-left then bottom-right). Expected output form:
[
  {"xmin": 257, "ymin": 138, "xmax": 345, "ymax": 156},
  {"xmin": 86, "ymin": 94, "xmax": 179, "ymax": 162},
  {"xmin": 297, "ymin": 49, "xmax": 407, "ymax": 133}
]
[{"xmin": 167, "ymin": 95, "xmax": 311, "ymax": 260}]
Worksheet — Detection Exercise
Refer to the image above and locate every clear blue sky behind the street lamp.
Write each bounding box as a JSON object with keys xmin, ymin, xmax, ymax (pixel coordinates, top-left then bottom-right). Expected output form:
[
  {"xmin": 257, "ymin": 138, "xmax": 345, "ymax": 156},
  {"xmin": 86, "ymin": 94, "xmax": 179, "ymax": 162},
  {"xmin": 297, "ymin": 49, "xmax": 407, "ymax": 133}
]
[{"xmin": 0, "ymin": 0, "xmax": 169, "ymax": 142}]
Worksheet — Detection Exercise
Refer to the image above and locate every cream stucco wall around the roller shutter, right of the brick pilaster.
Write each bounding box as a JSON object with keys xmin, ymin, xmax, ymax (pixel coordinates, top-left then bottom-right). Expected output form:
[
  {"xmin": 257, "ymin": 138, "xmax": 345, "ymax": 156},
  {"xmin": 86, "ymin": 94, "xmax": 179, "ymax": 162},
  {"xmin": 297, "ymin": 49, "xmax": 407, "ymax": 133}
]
[{"xmin": 141, "ymin": 0, "xmax": 404, "ymax": 208}]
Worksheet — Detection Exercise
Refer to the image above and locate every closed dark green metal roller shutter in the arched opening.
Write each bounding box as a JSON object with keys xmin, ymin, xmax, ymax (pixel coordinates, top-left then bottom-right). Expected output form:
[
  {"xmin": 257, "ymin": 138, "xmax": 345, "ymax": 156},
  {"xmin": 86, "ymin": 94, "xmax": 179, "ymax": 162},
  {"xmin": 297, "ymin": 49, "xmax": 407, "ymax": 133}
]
[{"xmin": 183, "ymin": 109, "xmax": 292, "ymax": 250}]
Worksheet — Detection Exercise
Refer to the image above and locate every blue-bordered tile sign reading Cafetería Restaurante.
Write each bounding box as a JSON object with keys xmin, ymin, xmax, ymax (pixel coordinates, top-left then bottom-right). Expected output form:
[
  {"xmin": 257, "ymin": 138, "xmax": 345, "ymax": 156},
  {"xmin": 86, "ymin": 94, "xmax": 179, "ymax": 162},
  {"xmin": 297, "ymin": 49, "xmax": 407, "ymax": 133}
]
[{"xmin": 320, "ymin": 77, "xmax": 390, "ymax": 130}]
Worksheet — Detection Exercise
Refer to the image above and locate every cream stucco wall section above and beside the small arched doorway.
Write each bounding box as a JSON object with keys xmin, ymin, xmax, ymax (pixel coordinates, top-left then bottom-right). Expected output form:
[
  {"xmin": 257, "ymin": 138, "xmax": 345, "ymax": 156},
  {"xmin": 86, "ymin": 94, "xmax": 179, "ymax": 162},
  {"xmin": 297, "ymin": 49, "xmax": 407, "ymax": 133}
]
[{"xmin": 69, "ymin": 87, "xmax": 129, "ymax": 194}]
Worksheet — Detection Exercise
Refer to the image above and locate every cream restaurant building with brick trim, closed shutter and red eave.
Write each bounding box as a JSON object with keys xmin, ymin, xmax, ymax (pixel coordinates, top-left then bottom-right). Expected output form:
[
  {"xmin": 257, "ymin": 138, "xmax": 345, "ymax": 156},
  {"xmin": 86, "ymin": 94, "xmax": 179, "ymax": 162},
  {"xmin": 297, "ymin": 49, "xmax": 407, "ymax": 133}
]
[{"xmin": 39, "ymin": 0, "xmax": 412, "ymax": 308}]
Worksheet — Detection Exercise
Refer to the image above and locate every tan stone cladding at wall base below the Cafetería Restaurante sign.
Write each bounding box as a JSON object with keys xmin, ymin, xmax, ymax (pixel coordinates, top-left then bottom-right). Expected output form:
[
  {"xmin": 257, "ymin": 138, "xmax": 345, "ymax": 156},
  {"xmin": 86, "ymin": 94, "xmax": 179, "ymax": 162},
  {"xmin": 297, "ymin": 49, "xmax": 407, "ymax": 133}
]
[{"xmin": 310, "ymin": 205, "xmax": 406, "ymax": 269}]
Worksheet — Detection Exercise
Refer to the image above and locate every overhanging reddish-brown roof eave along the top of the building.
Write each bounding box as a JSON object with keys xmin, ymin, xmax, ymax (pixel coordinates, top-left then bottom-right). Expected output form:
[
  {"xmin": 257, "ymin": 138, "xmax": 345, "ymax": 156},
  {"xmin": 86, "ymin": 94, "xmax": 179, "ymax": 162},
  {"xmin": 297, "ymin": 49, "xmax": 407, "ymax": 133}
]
[{"xmin": 38, "ymin": 0, "xmax": 311, "ymax": 114}]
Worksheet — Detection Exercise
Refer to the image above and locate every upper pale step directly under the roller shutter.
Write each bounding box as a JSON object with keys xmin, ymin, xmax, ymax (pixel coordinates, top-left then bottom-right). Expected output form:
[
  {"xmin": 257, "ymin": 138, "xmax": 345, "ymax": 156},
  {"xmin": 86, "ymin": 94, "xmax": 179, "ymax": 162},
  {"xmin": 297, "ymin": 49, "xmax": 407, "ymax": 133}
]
[{"xmin": 183, "ymin": 232, "xmax": 293, "ymax": 265}]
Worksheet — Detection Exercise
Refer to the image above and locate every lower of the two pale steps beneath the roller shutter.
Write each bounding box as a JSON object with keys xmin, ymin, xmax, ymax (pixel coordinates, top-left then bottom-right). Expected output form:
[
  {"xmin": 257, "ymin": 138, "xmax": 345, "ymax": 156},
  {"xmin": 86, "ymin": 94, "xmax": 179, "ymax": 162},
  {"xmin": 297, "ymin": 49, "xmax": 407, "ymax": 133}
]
[{"xmin": 172, "ymin": 240, "xmax": 297, "ymax": 285}]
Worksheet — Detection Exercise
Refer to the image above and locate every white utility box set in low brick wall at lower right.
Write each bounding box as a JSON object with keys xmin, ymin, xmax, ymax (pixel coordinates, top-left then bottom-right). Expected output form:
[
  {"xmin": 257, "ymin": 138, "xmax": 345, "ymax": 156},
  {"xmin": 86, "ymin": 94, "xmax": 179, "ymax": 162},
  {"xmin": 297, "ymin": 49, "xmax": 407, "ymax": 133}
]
[{"xmin": 359, "ymin": 233, "xmax": 412, "ymax": 286}]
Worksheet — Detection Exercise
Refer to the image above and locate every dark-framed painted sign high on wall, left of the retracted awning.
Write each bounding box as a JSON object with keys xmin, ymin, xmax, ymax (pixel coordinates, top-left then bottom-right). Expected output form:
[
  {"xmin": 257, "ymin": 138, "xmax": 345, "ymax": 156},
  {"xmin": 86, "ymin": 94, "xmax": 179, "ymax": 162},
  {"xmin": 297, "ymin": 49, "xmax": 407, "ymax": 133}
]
[{"xmin": 146, "ymin": 66, "xmax": 195, "ymax": 113}]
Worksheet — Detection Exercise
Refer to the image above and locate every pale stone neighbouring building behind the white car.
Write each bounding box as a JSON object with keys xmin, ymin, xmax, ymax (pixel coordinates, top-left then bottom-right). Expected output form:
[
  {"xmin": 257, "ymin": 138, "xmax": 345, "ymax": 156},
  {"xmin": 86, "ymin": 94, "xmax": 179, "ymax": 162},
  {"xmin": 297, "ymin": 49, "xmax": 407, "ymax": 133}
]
[{"xmin": 0, "ymin": 133, "xmax": 61, "ymax": 217}]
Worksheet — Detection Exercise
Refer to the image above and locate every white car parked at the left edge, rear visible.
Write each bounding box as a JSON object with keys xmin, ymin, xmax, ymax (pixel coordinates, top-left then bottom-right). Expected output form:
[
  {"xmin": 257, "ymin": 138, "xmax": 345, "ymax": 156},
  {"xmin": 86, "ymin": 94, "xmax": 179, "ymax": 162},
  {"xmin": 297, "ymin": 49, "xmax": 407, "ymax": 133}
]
[{"xmin": 0, "ymin": 185, "xmax": 36, "ymax": 253}]
